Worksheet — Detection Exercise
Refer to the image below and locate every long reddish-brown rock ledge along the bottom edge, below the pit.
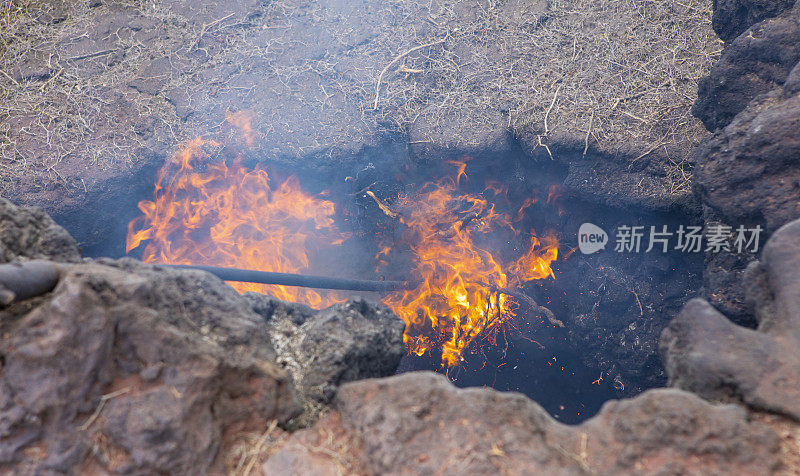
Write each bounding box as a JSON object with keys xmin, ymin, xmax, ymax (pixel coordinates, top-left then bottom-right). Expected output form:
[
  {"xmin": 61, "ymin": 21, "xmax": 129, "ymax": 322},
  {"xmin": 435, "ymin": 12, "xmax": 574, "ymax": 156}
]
[{"xmin": 262, "ymin": 372, "xmax": 781, "ymax": 475}]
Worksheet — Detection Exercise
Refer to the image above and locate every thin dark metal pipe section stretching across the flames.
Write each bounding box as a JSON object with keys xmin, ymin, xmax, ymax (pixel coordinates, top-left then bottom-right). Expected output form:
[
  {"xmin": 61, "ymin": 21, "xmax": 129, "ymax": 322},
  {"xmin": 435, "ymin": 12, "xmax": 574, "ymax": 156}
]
[{"xmin": 156, "ymin": 264, "xmax": 413, "ymax": 292}]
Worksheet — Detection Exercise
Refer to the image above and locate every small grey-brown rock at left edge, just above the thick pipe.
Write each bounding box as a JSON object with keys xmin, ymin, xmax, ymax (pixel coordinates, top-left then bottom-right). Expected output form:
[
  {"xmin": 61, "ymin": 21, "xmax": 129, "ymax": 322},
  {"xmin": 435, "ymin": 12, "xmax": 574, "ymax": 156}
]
[{"xmin": 0, "ymin": 198, "xmax": 81, "ymax": 263}]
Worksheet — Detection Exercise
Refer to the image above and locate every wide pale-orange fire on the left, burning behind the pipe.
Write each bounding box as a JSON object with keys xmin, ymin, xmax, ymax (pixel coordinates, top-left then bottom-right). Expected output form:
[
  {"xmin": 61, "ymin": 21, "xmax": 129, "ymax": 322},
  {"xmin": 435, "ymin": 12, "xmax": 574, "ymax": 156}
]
[{"xmin": 126, "ymin": 136, "xmax": 343, "ymax": 307}]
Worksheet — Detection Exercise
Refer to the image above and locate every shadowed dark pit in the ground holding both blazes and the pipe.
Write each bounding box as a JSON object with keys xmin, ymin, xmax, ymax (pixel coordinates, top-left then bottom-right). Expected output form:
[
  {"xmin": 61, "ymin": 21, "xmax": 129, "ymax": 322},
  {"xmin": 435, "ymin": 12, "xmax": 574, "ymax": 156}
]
[{"xmin": 95, "ymin": 117, "xmax": 701, "ymax": 422}]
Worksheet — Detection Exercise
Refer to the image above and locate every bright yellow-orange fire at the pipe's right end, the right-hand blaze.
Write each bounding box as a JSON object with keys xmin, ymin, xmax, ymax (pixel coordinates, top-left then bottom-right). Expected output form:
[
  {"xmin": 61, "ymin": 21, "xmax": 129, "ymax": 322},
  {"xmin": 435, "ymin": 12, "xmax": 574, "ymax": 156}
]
[{"xmin": 379, "ymin": 167, "xmax": 558, "ymax": 366}]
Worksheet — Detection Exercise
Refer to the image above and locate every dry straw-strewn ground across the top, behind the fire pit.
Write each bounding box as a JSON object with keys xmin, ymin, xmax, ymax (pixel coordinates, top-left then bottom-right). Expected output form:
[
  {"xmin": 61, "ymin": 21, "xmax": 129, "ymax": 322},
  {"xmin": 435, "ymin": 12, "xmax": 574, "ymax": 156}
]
[{"xmin": 0, "ymin": 0, "xmax": 721, "ymax": 201}]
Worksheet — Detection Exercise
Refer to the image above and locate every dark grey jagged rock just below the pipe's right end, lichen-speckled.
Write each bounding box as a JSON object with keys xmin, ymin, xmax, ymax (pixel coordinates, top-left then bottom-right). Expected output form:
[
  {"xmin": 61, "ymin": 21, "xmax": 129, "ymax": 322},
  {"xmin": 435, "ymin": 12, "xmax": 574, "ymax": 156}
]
[{"xmin": 246, "ymin": 293, "xmax": 406, "ymax": 426}]
